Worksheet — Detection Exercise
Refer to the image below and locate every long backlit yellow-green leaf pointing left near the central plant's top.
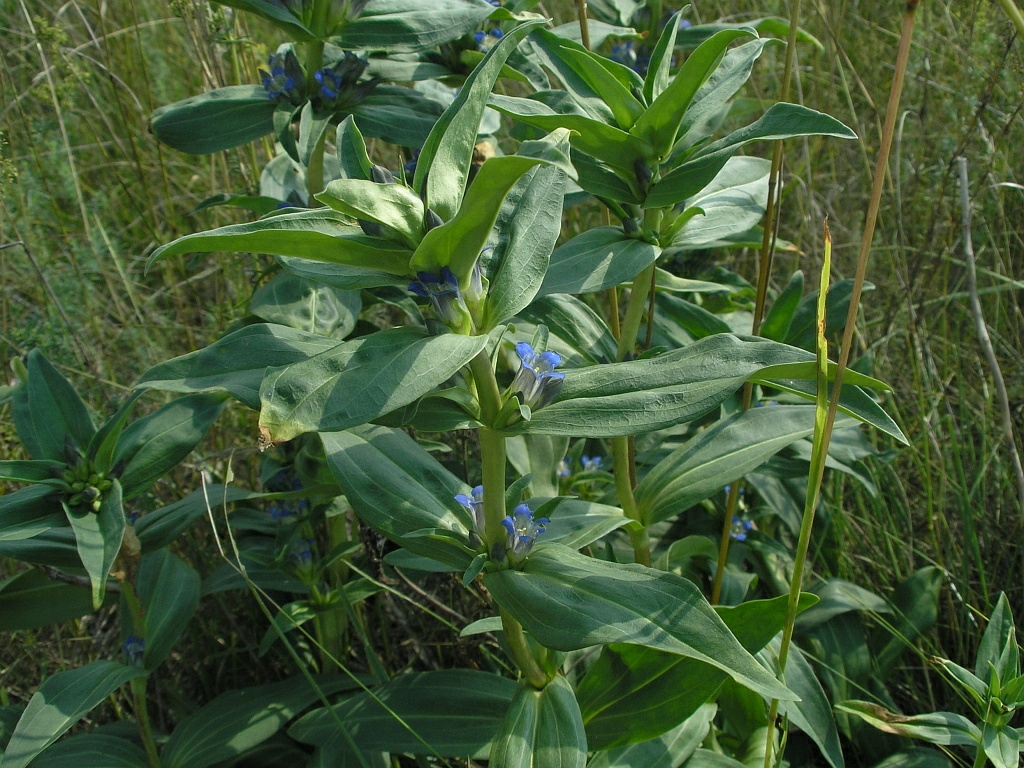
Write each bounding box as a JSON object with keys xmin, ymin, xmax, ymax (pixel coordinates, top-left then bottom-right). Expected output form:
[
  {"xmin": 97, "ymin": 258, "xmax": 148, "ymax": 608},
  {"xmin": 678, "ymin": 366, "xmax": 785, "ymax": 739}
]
[{"xmin": 148, "ymin": 209, "xmax": 413, "ymax": 275}]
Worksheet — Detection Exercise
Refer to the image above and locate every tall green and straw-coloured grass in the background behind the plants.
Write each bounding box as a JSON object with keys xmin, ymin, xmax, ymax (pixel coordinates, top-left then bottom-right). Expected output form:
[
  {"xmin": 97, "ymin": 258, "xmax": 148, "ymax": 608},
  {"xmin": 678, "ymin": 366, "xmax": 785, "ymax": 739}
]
[{"xmin": 0, "ymin": 0, "xmax": 1024, "ymax": 761}]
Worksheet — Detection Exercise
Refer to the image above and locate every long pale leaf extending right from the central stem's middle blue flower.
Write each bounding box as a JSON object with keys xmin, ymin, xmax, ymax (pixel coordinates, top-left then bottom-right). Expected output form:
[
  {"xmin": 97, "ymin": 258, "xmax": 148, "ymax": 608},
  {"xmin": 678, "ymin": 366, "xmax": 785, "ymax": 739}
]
[{"xmin": 506, "ymin": 334, "xmax": 811, "ymax": 437}]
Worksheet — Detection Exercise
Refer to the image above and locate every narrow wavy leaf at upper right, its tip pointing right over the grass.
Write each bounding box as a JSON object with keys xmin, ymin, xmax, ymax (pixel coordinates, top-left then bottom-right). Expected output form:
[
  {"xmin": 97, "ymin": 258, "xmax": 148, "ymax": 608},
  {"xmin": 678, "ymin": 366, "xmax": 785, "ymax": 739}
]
[{"xmin": 644, "ymin": 104, "xmax": 856, "ymax": 208}]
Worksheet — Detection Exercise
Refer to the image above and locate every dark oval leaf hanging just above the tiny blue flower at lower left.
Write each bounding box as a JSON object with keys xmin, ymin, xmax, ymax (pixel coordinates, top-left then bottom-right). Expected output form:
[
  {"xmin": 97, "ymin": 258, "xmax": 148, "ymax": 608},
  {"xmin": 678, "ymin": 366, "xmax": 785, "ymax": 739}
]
[{"xmin": 136, "ymin": 547, "xmax": 200, "ymax": 670}]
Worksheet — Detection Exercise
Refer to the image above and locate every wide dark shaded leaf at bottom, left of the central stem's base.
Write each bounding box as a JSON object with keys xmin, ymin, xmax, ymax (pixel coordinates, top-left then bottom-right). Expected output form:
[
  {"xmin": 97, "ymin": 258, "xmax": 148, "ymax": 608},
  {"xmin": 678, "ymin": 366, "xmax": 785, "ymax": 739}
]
[{"xmin": 290, "ymin": 670, "xmax": 516, "ymax": 753}]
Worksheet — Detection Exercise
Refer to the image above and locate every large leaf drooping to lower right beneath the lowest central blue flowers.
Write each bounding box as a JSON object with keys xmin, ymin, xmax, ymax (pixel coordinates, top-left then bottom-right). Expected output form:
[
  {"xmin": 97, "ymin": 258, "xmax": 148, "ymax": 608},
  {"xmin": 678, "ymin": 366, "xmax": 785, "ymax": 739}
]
[{"xmin": 483, "ymin": 544, "xmax": 795, "ymax": 700}]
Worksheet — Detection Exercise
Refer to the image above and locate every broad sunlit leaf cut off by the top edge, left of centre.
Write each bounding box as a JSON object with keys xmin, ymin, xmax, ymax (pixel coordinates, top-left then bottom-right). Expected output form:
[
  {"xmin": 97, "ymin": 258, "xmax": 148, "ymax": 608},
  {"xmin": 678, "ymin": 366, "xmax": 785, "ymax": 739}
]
[{"xmin": 331, "ymin": 0, "xmax": 495, "ymax": 52}]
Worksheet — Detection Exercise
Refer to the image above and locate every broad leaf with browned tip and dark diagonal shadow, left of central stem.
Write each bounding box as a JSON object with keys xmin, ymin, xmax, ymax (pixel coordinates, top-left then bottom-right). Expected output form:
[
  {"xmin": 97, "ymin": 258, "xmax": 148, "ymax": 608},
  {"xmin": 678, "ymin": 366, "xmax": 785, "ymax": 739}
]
[{"xmin": 260, "ymin": 326, "xmax": 487, "ymax": 441}]
